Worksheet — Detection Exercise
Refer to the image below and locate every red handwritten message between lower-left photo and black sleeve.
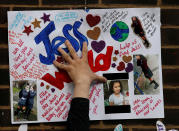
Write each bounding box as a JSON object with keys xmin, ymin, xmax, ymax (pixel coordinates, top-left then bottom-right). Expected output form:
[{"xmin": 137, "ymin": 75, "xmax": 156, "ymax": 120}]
[{"xmin": 39, "ymin": 91, "xmax": 72, "ymax": 121}]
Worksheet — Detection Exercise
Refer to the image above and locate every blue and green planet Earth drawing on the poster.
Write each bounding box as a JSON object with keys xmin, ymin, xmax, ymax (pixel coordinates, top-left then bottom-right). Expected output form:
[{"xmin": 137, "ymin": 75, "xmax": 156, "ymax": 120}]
[{"xmin": 110, "ymin": 21, "xmax": 129, "ymax": 42}]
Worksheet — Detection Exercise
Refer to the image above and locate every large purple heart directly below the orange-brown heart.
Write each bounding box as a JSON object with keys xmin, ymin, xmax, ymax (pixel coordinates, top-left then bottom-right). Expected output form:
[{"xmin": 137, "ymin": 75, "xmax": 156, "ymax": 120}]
[{"xmin": 91, "ymin": 40, "xmax": 106, "ymax": 53}]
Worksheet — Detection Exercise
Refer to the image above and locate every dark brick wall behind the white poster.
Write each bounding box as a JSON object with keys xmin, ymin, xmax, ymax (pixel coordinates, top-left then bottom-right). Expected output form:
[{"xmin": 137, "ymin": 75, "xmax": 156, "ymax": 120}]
[{"xmin": 0, "ymin": 0, "xmax": 179, "ymax": 131}]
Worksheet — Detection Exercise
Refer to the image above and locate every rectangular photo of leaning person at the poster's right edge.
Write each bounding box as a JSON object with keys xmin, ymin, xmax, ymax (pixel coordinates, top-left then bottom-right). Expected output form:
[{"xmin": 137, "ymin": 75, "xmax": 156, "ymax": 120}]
[{"xmin": 133, "ymin": 54, "xmax": 160, "ymax": 95}]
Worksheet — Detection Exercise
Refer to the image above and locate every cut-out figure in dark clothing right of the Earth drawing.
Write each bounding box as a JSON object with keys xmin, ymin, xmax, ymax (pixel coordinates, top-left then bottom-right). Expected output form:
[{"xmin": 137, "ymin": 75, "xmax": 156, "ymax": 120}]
[{"xmin": 131, "ymin": 16, "xmax": 150, "ymax": 48}]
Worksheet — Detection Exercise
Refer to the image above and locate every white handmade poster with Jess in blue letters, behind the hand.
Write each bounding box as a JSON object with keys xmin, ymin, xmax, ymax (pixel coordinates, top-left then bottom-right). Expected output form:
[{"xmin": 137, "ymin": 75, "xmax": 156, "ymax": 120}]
[{"xmin": 8, "ymin": 8, "xmax": 164, "ymax": 124}]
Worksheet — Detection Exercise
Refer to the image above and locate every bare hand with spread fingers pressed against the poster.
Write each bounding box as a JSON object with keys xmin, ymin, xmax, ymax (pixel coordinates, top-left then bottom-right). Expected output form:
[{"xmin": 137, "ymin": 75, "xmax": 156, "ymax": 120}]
[{"xmin": 53, "ymin": 40, "xmax": 106, "ymax": 97}]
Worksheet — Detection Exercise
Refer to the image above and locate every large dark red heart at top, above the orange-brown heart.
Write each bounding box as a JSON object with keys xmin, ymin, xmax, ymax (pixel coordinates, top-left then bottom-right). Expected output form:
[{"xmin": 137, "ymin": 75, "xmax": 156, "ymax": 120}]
[{"xmin": 86, "ymin": 14, "xmax": 101, "ymax": 27}]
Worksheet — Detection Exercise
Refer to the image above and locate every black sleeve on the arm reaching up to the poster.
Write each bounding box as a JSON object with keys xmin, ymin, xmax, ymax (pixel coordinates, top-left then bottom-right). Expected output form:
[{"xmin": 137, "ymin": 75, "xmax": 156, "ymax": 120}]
[{"xmin": 67, "ymin": 98, "xmax": 89, "ymax": 131}]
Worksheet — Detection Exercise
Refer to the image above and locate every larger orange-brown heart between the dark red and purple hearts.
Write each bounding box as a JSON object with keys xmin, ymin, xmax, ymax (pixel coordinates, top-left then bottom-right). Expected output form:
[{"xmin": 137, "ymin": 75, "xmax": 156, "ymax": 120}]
[{"xmin": 86, "ymin": 27, "xmax": 101, "ymax": 40}]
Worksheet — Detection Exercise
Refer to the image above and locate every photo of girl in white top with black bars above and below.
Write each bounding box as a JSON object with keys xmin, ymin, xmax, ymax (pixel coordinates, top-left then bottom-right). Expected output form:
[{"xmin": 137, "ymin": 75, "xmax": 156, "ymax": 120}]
[{"xmin": 103, "ymin": 73, "xmax": 130, "ymax": 114}]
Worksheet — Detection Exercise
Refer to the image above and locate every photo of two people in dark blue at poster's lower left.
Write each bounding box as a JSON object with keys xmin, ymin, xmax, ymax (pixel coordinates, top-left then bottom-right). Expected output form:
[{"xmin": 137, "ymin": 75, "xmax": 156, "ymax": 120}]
[{"xmin": 13, "ymin": 80, "xmax": 37, "ymax": 122}]
